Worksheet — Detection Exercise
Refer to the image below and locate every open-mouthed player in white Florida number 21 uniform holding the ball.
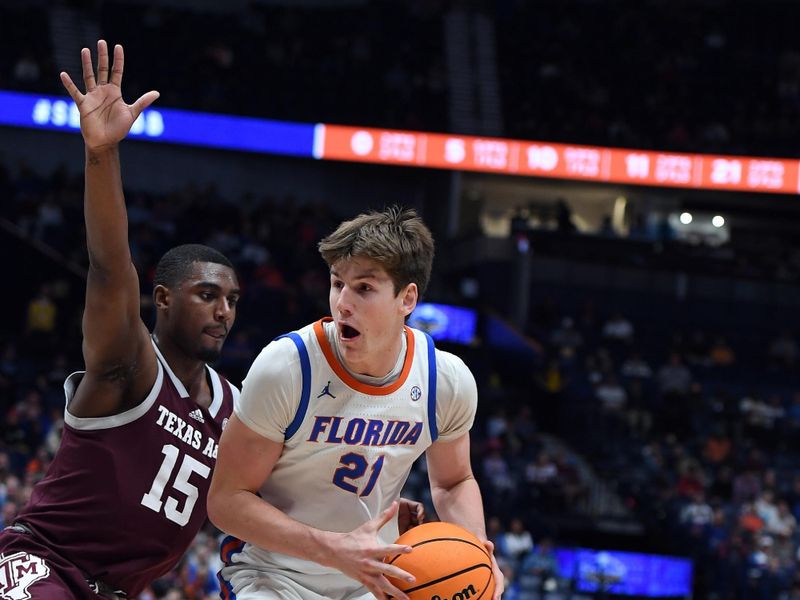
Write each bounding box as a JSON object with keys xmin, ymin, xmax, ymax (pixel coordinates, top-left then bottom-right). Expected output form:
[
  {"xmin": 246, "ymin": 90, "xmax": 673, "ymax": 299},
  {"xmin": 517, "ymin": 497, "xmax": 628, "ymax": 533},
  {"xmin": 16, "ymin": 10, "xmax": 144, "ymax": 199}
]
[{"xmin": 208, "ymin": 208, "xmax": 503, "ymax": 600}]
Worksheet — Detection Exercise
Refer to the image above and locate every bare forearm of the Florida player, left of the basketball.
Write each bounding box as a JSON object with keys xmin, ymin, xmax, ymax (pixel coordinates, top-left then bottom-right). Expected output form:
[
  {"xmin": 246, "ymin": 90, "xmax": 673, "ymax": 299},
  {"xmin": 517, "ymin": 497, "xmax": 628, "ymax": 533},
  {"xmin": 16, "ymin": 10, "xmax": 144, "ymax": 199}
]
[{"xmin": 208, "ymin": 490, "xmax": 341, "ymax": 565}]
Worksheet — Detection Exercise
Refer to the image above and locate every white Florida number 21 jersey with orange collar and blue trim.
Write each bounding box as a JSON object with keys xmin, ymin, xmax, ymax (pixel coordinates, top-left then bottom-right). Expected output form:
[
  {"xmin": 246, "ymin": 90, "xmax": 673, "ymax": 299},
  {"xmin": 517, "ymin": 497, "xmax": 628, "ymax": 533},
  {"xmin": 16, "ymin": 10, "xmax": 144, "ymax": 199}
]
[{"xmin": 223, "ymin": 321, "xmax": 438, "ymax": 575}]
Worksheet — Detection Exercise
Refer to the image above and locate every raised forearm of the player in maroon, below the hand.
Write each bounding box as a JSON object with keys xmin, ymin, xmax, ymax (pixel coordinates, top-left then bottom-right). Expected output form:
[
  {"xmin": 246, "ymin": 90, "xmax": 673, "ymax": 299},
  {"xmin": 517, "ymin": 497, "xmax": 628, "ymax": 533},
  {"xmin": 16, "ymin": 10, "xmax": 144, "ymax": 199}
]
[{"xmin": 84, "ymin": 146, "xmax": 131, "ymax": 274}]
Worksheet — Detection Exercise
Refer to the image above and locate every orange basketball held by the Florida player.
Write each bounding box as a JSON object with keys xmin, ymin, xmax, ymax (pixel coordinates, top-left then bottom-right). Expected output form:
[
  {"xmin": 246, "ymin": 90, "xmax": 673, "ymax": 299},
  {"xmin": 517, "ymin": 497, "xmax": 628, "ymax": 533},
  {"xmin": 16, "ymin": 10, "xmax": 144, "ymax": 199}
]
[{"xmin": 386, "ymin": 523, "xmax": 494, "ymax": 600}]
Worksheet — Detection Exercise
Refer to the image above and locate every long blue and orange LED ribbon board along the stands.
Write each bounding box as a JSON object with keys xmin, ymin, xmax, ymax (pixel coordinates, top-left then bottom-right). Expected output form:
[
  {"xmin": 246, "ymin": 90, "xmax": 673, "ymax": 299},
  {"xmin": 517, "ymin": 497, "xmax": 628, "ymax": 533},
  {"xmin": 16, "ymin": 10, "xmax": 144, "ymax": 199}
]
[{"xmin": 0, "ymin": 91, "xmax": 800, "ymax": 194}]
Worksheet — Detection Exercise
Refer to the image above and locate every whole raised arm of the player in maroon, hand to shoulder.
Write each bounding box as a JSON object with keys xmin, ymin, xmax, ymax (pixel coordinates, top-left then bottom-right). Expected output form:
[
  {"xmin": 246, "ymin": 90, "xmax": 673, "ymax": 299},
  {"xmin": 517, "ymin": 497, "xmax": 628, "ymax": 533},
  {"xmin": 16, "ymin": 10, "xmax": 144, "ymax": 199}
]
[{"xmin": 61, "ymin": 40, "xmax": 158, "ymax": 417}]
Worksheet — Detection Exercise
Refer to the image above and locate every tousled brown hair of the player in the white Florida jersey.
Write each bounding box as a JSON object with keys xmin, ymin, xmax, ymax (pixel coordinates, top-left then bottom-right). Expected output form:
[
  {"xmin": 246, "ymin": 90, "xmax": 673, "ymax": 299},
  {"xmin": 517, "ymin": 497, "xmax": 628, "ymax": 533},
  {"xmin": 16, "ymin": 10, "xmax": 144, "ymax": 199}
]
[{"xmin": 319, "ymin": 206, "xmax": 434, "ymax": 296}]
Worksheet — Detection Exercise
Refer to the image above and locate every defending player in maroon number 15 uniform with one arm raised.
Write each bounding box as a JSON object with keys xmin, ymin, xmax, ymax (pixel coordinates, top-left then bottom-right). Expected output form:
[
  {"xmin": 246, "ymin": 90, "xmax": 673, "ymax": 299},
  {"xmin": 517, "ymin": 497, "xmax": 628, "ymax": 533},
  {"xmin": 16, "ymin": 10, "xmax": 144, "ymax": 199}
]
[{"xmin": 0, "ymin": 41, "xmax": 239, "ymax": 600}]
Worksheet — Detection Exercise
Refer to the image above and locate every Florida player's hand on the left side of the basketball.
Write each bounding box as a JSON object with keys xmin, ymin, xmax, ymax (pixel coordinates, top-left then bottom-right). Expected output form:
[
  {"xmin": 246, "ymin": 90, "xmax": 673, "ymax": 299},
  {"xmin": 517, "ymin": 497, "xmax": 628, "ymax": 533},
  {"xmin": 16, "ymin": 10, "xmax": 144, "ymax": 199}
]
[{"xmin": 329, "ymin": 502, "xmax": 413, "ymax": 600}]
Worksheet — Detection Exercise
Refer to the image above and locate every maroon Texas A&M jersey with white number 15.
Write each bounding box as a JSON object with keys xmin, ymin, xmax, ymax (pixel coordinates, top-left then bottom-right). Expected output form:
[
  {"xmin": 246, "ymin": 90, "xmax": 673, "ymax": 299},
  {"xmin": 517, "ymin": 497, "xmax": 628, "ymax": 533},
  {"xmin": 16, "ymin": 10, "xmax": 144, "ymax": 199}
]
[{"xmin": 17, "ymin": 340, "xmax": 239, "ymax": 597}]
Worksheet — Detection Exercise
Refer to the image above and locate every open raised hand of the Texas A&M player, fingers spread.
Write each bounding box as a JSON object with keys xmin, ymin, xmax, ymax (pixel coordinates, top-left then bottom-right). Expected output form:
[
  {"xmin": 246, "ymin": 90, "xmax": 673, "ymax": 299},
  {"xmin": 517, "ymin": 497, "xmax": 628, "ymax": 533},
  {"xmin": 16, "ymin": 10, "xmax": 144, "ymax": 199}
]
[{"xmin": 61, "ymin": 40, "xmax": 159, "ymax": 150}]
